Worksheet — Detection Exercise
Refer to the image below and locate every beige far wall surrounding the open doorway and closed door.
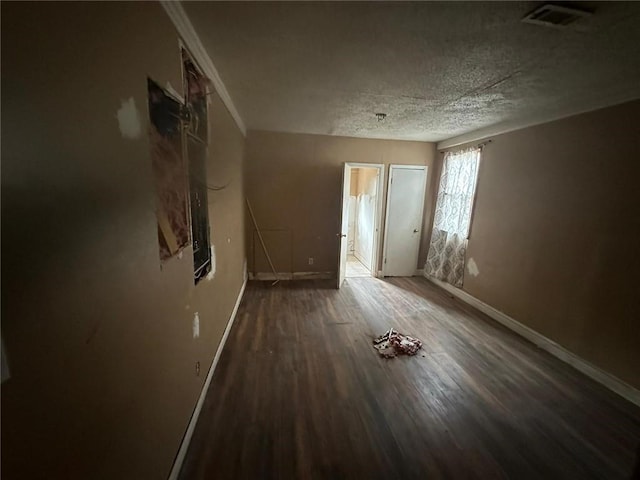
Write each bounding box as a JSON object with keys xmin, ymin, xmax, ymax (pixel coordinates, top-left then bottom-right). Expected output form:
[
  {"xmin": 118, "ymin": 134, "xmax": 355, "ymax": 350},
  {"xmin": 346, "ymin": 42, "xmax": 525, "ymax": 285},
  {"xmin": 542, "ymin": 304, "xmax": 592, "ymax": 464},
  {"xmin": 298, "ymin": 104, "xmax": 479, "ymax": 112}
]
[{"xmin": 245, "ymin": 131, "xmax": 435, "ymax": 273}]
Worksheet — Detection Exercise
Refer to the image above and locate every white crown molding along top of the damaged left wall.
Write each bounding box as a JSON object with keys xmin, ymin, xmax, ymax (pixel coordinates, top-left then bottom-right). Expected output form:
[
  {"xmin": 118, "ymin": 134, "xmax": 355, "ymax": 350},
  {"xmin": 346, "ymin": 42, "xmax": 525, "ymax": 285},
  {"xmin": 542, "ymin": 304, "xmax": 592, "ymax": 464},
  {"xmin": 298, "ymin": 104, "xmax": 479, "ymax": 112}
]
[{"xmin": 160, "ymin": 0, "xmax": 247, "ymax": 136}]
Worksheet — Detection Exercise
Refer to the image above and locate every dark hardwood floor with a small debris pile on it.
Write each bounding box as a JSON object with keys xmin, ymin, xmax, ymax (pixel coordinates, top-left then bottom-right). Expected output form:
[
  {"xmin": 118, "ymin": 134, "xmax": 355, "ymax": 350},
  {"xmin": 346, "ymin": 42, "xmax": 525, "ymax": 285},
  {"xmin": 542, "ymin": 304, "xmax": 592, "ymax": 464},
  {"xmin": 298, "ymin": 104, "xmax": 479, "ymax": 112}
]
[{"xmin": 181, "ymin": 278, "xmax": 640, "ymax": 480}]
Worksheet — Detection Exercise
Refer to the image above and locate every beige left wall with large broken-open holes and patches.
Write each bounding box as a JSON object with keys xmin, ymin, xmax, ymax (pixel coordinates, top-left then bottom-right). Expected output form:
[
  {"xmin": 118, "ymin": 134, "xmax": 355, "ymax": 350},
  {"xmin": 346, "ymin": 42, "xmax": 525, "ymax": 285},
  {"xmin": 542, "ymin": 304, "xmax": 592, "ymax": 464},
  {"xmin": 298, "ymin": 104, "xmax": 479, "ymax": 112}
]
[{"xmin": 2, "ymin": 2, "xmax": 245, "ymax": 480}]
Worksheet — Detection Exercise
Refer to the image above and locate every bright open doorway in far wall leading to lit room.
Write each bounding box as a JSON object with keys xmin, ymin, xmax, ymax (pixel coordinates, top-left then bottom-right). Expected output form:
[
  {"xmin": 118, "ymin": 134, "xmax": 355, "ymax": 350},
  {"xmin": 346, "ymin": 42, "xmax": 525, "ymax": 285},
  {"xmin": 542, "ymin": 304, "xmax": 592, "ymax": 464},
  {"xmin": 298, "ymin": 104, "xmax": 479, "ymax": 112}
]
[{"xmin": 339, "ymin": 163, "xmax": 384, "ymax": 284}]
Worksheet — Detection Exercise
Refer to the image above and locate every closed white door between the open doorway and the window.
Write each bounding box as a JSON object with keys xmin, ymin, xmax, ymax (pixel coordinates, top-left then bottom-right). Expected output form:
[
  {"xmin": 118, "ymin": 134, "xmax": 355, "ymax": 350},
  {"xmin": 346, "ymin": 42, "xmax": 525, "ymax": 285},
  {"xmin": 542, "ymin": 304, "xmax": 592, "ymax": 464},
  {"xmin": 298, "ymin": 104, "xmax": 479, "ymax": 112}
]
[{"xmin": 382, "ymin": 165, "xmax": 427, "ymax": 277}]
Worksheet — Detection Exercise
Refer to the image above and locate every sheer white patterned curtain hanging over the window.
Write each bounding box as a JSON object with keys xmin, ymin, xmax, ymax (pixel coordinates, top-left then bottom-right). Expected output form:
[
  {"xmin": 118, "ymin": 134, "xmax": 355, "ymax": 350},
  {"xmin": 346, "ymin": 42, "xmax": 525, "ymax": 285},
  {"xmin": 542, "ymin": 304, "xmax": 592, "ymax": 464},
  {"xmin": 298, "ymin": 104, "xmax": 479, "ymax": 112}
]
[{"xmin": 424, "ymin": 148, "xmax": 481, "ymax": 287}]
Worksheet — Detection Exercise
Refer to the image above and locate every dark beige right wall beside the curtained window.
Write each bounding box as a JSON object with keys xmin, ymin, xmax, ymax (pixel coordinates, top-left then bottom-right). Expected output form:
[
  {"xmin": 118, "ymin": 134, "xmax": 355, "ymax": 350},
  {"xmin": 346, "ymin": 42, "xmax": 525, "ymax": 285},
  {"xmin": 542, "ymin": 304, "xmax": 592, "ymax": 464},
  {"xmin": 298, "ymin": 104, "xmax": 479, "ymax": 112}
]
[{"xmin": 450, "ymin": 101, "xmax": 640, "ymax": 388}]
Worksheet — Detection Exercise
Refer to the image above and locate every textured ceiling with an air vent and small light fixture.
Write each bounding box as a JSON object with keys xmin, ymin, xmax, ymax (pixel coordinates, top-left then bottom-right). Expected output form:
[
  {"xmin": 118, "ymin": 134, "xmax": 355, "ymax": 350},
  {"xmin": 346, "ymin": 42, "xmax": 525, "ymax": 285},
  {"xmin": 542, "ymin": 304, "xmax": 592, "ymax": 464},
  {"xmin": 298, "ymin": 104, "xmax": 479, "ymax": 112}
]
[{"xmin": 184, "ymin": 2, "xmax": 640, "ymax": 141}]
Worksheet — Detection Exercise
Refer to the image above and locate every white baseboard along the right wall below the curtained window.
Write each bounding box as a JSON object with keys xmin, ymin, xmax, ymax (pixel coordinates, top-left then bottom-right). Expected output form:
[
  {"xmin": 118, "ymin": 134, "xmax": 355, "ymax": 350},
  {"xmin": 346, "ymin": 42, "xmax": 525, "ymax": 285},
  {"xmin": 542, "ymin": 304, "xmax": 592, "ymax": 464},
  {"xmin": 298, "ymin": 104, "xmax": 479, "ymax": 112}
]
[{"xmin": 425, "ymin": 275, "xmax": 640, "ymax": 406}]
